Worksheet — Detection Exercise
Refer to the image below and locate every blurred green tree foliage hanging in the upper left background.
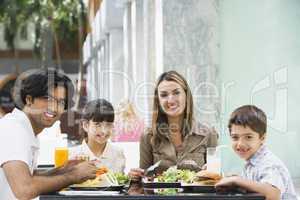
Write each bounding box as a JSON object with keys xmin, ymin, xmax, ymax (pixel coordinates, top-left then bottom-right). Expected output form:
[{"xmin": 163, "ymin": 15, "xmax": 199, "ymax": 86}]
[{"xmin": 0, "ymin": 0, "xmax": 86, "ymax": 53}]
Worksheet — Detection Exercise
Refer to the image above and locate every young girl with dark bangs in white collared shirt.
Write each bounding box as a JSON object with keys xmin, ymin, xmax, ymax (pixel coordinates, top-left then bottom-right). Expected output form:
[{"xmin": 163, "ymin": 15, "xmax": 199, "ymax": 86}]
[{"xmin": 70, "ymin": 99, "xmax": 125, "ymax": 172}]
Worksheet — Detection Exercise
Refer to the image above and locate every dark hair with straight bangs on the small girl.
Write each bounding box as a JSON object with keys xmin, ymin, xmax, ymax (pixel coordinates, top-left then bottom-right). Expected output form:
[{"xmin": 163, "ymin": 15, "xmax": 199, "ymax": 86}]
[{"xmin": 82, "ymin": 99, "xmax": 115, "ymax": 122}]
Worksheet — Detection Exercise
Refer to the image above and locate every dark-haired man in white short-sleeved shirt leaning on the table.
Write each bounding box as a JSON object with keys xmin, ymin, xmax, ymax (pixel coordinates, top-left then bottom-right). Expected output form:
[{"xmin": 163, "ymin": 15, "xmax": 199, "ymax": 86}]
[{"xmin": 0, "ymin": 69, "xmax": 96, "ymax": 200}]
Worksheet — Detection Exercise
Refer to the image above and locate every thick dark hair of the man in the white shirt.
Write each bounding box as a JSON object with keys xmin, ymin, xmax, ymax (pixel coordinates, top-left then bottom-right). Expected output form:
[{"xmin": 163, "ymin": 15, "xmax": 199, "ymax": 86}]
[{"xmin": 13, "ymin": 68, "xmax": 74, "ymax": 110}]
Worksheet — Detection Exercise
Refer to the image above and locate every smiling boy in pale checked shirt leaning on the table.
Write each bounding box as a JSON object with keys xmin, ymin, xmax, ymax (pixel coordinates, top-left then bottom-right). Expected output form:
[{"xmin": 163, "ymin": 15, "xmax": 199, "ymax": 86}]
[{"xmin": 216, "ymin": 105, "xmax": 297, "ymax": 200}]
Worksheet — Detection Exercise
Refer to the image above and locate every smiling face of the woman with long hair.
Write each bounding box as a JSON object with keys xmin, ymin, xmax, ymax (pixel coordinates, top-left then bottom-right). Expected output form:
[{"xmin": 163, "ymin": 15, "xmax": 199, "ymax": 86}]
[{"xmin": 157, "ymin": 81, "xmax": 186, "ymax": 117}]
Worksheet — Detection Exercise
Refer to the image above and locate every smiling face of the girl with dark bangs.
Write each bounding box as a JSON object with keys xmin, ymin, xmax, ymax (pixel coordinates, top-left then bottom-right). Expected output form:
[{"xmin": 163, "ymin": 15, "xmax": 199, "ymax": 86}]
[{"xmin": 83, "ymin": 120, "xmax": 114, "ymax": 144}]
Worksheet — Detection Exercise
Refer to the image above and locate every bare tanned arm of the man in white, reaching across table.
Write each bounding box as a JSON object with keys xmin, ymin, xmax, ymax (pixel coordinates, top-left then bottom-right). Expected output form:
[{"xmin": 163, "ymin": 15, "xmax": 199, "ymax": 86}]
[{"xmin": 2, "ymin": 161, "xmax": 96, "ymax": 200}]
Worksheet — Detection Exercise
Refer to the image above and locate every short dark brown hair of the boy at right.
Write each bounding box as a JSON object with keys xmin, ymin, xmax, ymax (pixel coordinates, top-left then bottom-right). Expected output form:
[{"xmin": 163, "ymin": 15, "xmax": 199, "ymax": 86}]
[{"xmin": 228, "ymin": 105, "xmax": 267, "ymax": 137}]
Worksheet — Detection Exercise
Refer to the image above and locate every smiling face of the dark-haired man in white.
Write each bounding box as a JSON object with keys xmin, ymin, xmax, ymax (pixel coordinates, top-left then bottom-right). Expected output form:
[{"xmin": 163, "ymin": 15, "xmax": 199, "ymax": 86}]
[{"xmin": 26, "ymin": 86, "xmax": 66, "ymax": 131}]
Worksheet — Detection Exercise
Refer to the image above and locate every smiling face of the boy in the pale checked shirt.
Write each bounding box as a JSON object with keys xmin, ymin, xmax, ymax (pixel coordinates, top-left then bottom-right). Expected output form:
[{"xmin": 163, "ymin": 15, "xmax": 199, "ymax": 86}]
[{"xmin": 230, "ymin": 124, "xmax": 265, "ymax": 160}]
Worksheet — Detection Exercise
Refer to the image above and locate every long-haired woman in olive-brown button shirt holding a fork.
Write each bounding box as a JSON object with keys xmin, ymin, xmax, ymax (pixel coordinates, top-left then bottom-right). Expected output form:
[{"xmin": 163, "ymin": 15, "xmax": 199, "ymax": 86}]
[{"xmin": 129, "ymin": 71, "xmax": 218, "ymax": 180}]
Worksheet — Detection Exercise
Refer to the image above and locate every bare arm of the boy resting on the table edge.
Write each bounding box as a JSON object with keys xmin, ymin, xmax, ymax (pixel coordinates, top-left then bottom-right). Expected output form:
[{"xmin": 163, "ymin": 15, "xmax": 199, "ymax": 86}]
[{"xmin": 216, "ymin": 176, "xmax": 280, "ymax": 200}]
